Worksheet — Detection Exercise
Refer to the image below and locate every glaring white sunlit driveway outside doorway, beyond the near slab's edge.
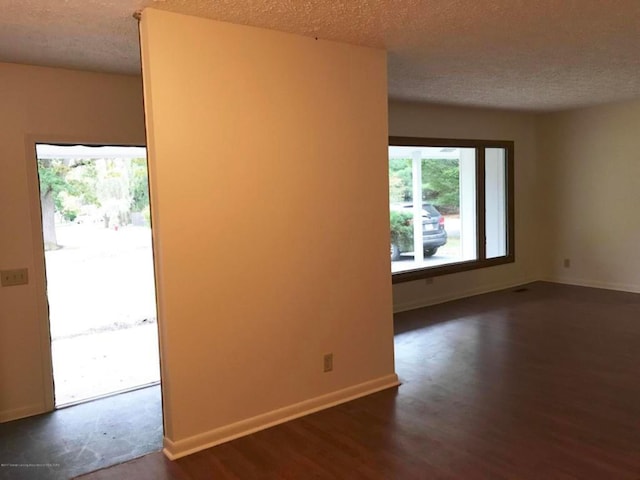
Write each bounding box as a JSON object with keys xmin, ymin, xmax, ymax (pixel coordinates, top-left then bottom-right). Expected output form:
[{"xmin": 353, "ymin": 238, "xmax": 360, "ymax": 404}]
[{"xmin": 45, "ymin": 224, "xmax": 156, "ymax": 339}]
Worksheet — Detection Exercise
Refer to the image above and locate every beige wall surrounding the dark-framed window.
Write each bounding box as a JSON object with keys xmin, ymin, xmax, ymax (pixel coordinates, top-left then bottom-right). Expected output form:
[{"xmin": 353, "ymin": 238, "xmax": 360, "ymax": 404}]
[{"xmin": 389, "ymin": 101, "xmax": 547, "ymax": 311}]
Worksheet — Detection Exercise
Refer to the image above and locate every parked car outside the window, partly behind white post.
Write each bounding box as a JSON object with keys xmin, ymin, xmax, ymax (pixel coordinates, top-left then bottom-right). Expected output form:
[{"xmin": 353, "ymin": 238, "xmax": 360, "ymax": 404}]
[{"xmin": 389, "ymin": 203, "xmax": 447, "ymax": 261}]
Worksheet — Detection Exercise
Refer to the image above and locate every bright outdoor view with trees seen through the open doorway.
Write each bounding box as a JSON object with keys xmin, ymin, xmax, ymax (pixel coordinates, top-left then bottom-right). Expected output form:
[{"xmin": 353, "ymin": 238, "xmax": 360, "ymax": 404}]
[{"xmin": 36, "ymin": 144, "xmax": 160, "ymax": 407}]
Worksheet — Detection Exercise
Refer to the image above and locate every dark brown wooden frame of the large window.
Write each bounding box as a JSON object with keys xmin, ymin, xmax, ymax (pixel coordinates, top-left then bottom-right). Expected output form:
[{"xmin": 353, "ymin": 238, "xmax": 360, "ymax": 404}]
[{"xmin": 387, "ymin": 136, "xmax": 515, "ymax": 284}]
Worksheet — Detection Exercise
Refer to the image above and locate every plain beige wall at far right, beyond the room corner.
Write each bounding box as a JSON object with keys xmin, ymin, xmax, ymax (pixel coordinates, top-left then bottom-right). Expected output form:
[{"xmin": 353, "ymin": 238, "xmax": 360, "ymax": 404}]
[{"xmin": 538, "ymin": 100, "xmax": 640, "ymax": 292}]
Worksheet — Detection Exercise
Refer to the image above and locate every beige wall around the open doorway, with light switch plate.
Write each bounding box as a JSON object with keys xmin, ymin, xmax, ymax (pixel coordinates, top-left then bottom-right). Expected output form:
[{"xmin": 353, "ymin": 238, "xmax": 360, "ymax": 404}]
[{"xmin": 0, "ymin": 63, "xmax": 145, "ymax": 421}]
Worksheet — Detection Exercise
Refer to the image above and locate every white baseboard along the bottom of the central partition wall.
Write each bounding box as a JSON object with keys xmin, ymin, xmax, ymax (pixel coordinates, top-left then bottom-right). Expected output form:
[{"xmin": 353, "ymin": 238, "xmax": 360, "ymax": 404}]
[{"xmin": 163, "ymin": 374, "xmax": 400, "ymax": 460}]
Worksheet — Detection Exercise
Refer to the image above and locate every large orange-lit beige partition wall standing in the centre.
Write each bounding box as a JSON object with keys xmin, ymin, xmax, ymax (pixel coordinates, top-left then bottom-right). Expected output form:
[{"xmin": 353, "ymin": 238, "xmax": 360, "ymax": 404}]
[{"xmin": 141, "ymin": 9, "xmax": 394, "ymax": 455}]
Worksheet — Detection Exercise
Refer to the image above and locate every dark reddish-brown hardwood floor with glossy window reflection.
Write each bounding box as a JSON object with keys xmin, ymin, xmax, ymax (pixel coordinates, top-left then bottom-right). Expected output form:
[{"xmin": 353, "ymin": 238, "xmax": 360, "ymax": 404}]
[{"xmin": 82, "ymin": 283, "xmax": 640, "ymax": 480}]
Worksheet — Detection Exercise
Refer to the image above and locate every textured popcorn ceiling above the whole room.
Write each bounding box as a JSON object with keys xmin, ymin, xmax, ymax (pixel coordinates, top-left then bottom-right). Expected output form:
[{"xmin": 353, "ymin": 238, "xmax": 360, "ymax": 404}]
[{"xmin": 0, "ymin": 0, "xmax": 640, "ymax": 111}]
